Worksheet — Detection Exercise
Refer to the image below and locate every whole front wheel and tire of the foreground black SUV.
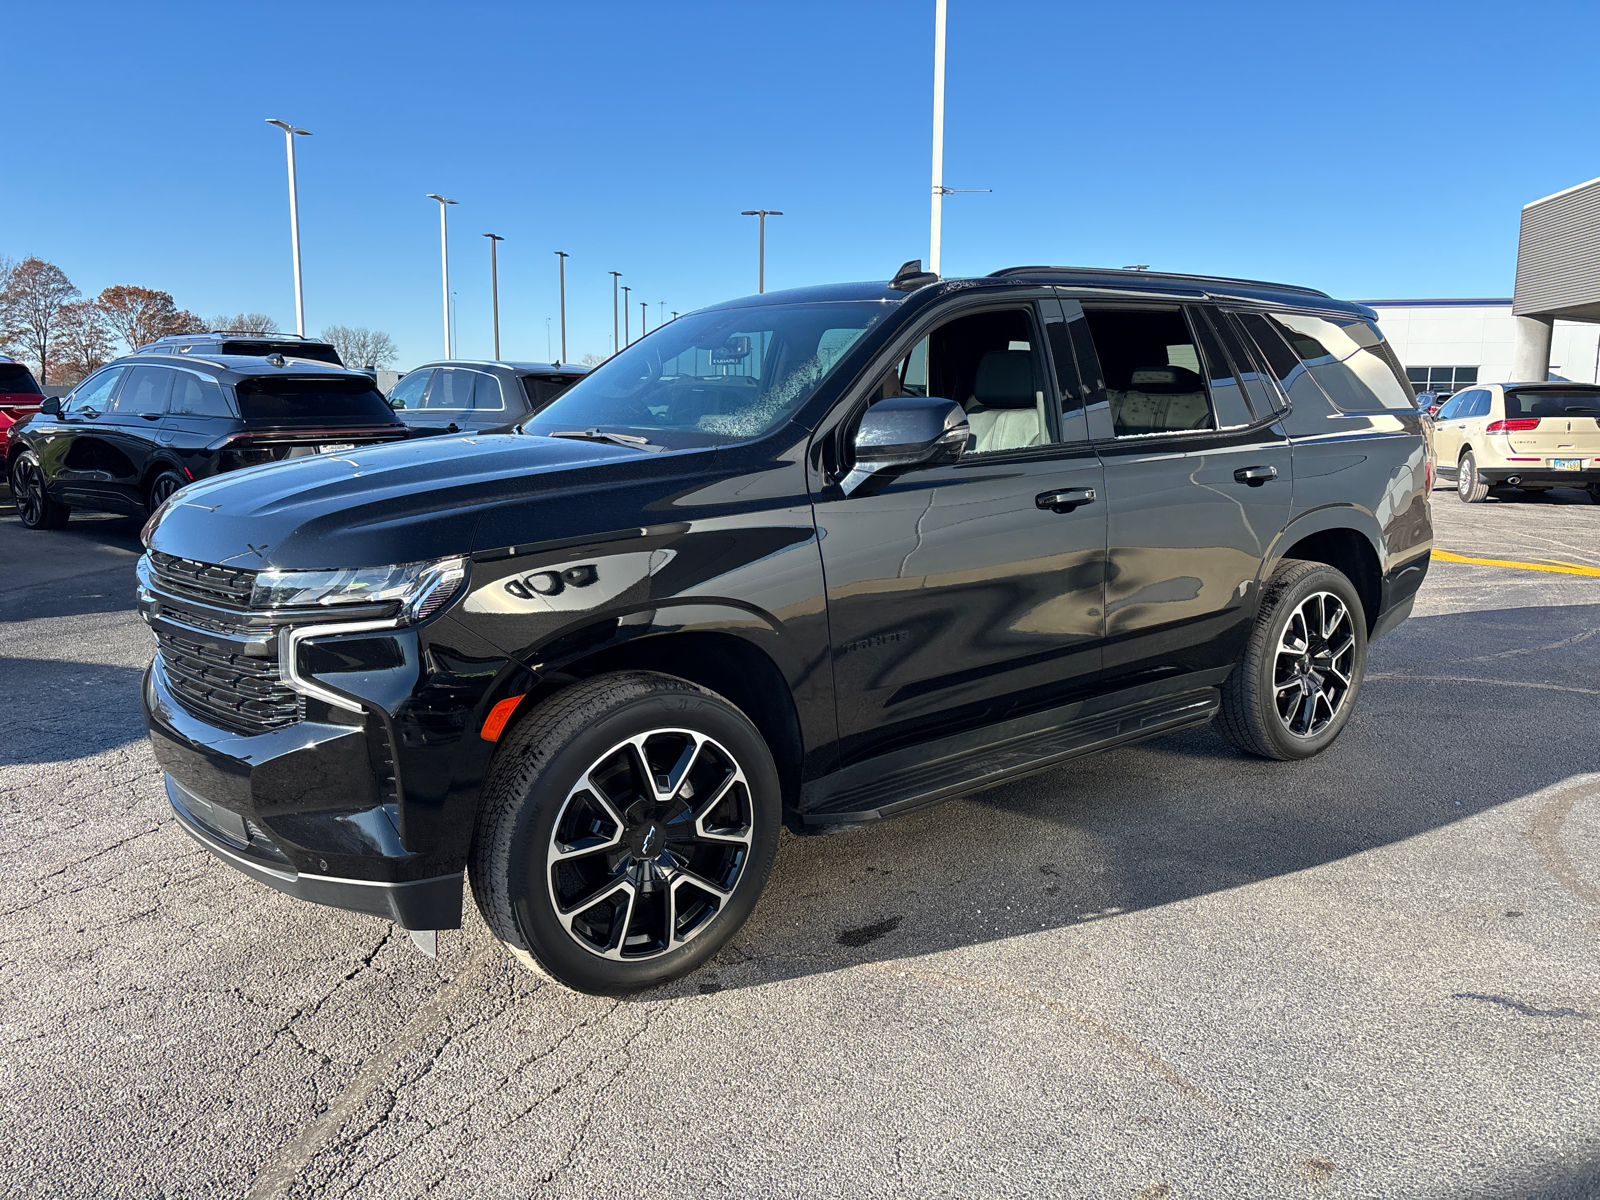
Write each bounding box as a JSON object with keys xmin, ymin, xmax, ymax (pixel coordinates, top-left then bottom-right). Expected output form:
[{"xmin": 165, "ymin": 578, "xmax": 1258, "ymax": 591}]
[{"xmin": 470, "ymin": 672, "xmax": 782, "ymax": 995}]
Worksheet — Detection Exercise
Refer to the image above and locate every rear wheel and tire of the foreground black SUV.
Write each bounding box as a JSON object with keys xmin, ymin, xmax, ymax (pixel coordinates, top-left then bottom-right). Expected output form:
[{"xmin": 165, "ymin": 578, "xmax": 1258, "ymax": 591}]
[{"xmin": 1216, "ymin": 558, "xmax": 1366, "ymax": 760}]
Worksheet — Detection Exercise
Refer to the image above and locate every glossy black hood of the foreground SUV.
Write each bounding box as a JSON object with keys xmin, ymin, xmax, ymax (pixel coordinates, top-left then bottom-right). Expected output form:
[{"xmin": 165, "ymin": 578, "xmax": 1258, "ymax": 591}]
[{"xmin": 149, "ymin": 434, "xmax": 681, "ymax": 570}]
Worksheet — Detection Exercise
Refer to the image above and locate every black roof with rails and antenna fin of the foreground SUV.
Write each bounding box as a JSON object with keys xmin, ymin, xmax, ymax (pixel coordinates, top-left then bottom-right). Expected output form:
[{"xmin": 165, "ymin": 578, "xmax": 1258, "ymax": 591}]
[{"xmin": 704, "ymin": 266, "xmax": 1378, "ymax": 320}]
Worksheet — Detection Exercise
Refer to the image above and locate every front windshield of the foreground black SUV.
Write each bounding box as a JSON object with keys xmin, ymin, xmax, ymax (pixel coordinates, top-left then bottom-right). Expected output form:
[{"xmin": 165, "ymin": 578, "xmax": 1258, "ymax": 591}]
[{"xmin": 522, "ymin": 301, "xmax": 888, "ymax": 450}]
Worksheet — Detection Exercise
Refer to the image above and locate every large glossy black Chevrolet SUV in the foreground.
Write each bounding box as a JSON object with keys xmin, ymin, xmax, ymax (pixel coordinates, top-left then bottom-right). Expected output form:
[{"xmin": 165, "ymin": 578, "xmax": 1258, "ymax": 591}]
[{"xmin": 138, "ymin": 264, "xmax": 1432, "ymax": 992}]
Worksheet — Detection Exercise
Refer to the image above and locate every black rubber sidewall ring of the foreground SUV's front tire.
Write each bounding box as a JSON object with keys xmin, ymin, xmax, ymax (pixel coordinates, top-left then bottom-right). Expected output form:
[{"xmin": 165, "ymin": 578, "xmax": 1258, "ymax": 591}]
[{"xmin": 507, "ymin": 690, "xmax": 782, "ymax": 994}]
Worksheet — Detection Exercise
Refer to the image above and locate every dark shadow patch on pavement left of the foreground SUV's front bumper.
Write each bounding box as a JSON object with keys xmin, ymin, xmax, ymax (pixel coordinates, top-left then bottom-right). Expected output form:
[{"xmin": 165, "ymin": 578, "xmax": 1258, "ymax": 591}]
[{"xmin": 0, "ymin": 658, "xmax": 144, "ymax": 766}]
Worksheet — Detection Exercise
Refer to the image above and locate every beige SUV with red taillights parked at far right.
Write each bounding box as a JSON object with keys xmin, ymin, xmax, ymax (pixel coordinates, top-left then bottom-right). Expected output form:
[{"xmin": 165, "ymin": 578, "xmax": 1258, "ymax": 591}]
[{"xmin": 1434, "ymin": 382, "xmax": 1600, "ymax": 504}]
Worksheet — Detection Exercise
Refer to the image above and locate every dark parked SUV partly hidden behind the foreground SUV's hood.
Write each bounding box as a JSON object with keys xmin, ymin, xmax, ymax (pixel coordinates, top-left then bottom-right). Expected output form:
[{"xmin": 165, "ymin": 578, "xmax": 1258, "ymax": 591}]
[{"xmin": 389, "ymin": 358, "xmax": 589, "ymax": 435}]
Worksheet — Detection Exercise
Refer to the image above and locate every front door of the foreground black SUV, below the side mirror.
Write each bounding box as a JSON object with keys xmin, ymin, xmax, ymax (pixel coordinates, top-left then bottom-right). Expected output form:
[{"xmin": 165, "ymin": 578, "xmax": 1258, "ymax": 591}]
[{"xmin": 816, "ymin": 309, "xmax": 1106, "ymax": 762}]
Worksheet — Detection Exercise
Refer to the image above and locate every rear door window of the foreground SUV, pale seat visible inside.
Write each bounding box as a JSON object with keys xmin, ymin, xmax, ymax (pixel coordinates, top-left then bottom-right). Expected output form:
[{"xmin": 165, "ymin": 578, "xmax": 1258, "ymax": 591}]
[{"xmin": 1085, "ymin": 307, "xmax": 1216, "ymax": 437}]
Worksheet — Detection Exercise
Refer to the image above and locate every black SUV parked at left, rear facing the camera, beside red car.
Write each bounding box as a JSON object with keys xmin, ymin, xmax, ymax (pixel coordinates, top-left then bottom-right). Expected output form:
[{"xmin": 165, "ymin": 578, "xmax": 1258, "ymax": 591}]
[{"xmin": 5, "ymin": 354, "xmax": 408, "ymax": 530}]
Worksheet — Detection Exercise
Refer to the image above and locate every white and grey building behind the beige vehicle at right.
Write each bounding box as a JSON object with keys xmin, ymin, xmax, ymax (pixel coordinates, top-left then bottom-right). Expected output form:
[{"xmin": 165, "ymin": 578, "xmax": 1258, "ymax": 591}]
[{"xmin": 1365, "ymin": 179, "xmax": 1600, "ymax": 400}]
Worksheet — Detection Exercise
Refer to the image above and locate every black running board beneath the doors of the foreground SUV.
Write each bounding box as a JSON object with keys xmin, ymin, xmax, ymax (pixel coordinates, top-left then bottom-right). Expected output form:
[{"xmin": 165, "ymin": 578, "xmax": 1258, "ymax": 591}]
[{"xmin": 802, "ymin": 688, "xmax": 1222, "ymax": 826}]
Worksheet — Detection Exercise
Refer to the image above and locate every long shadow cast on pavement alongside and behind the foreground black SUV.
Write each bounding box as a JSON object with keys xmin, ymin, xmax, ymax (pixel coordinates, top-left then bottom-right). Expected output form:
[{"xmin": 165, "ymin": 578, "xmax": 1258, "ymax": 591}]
[{"xmin": 704, "ymin": 605, "xmax": 1600, "ymax": 1000}]
